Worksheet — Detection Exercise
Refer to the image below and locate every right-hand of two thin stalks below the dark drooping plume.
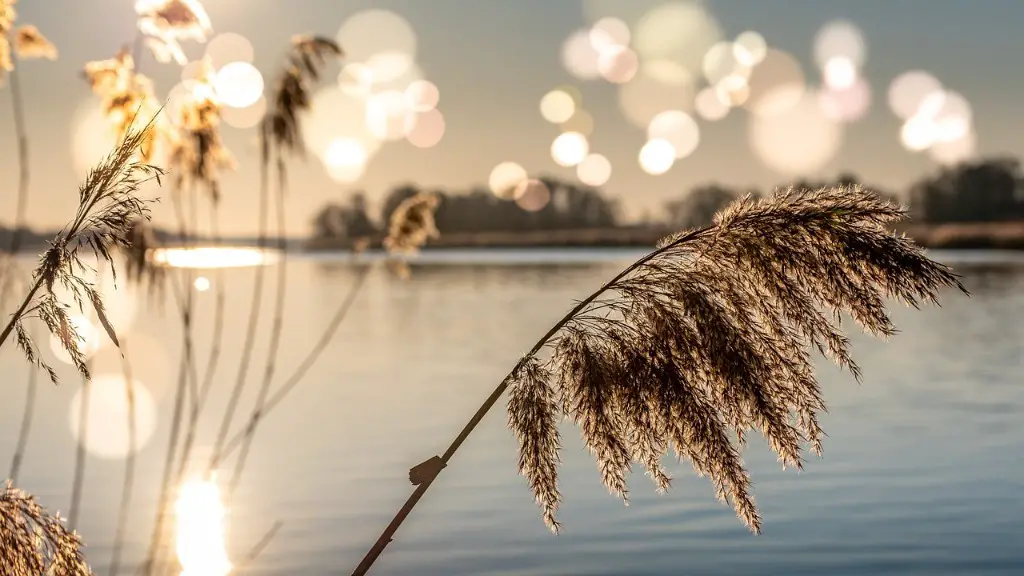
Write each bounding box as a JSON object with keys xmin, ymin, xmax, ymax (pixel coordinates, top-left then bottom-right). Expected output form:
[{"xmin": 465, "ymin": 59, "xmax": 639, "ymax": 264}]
[{"xmin": 226, "ymin": 147, "xmax": 288, "ymax": 502}]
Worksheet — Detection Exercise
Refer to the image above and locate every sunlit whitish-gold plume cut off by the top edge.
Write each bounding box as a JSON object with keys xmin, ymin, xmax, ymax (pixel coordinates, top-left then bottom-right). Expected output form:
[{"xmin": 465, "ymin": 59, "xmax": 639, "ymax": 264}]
[{"xmin": 135, "ymin": 0, "xmax": 213, "ymax": 66}]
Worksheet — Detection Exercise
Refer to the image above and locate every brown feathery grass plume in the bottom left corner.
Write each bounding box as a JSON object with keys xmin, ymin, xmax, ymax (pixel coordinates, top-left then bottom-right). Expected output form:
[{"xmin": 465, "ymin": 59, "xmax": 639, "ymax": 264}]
[{"xmin": 0, "ymin": 482, "xmax": 92, "ymax": 576}]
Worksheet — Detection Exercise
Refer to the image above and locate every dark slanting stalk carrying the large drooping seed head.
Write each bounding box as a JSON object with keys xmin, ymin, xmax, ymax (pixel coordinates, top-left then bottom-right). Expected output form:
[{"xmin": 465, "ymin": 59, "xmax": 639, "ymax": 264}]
[{"xmin": 352, "ymin": 229, "xmax": 710, "ymax": 576}]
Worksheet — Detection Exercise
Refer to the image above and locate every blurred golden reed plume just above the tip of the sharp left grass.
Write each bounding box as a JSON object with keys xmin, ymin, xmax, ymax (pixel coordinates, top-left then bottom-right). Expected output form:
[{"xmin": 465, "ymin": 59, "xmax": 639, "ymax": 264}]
[{"xmin": 83, "ymin": 48, "xmax": 167, "ymax": 163}]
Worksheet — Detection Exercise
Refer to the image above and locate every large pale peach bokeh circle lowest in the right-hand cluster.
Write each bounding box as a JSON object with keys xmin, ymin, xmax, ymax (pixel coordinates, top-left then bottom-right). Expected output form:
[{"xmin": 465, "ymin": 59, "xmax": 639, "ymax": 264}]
[{"xmin": 749, "ymin": 87, "xmax": 843, "ymax": 176}]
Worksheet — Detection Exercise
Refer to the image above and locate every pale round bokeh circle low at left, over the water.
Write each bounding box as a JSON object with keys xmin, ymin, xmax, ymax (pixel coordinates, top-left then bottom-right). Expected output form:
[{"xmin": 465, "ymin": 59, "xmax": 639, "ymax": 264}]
[{"xmin": 68, "ymin": 375, "xmax": 157, "ymax": 459}]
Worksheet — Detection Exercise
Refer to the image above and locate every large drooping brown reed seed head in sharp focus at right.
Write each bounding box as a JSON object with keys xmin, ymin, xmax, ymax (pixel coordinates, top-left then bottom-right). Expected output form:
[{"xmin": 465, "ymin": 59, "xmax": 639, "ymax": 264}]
[{"xmin": 508, "ymin": 187, "xmax": 966, "ymax": 532}]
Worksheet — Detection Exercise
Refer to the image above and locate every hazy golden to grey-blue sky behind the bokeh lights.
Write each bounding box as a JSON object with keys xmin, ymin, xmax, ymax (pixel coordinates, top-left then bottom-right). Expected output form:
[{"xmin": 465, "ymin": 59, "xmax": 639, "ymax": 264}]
[{"xmin": 0, "ymin": 0, "xmax": 1024, "ymax": 236}]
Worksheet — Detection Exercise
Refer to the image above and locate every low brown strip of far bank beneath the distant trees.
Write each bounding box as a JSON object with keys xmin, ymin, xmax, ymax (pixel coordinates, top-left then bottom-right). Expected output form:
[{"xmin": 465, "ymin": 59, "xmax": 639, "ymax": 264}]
[{"xmin": 304, "ymin": 221, "xmax": 1024, "ymax": 251}]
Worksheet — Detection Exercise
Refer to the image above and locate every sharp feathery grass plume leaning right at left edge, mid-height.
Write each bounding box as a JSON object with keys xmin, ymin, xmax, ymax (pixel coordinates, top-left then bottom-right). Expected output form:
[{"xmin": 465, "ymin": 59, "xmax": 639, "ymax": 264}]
[{"xmin": 0, "ymin": 113, "xmax": 163, "ymax": 383}]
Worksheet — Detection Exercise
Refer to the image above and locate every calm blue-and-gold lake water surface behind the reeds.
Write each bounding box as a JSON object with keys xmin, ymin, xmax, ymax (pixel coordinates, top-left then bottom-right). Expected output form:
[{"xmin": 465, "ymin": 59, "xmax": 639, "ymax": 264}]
[{"xmin": 0, "ymin": 251, "xmax": 1024, "ymax": 576}]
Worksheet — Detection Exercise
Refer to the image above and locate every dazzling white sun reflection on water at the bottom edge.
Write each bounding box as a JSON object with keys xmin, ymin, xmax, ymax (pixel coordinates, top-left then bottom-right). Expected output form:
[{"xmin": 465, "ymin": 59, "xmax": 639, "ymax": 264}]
[{"xmin": 174, "ymin": 479, "xmax": 231, "ymax": 576}]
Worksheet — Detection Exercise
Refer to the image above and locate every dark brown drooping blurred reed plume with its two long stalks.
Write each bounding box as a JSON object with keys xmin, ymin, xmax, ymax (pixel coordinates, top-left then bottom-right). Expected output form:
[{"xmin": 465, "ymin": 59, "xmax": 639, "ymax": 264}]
[{"xmin": 214, "ymin": 35, "xmax": 342, "ymax": 499}]
